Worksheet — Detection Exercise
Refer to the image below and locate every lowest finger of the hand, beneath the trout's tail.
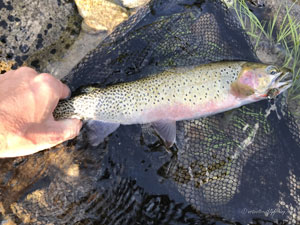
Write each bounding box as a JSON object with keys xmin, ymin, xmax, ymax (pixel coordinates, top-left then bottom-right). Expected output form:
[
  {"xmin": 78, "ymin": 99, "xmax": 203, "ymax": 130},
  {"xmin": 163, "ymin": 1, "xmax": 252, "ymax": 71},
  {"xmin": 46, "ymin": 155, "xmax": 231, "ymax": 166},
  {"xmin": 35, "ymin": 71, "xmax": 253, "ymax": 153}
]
[{"xmin": 26, "ymin": 119, "xmax": 82, "ymax": 150}]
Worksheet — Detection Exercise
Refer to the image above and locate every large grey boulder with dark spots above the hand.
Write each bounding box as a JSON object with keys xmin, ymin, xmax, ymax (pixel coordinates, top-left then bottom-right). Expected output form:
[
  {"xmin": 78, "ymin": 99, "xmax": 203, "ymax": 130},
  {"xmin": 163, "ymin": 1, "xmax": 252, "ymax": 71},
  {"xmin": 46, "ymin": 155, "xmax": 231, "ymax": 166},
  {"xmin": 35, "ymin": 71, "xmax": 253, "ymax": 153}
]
[{"xmin": 0, "ymin": 0, "xmax": 81, "ymax": 72}]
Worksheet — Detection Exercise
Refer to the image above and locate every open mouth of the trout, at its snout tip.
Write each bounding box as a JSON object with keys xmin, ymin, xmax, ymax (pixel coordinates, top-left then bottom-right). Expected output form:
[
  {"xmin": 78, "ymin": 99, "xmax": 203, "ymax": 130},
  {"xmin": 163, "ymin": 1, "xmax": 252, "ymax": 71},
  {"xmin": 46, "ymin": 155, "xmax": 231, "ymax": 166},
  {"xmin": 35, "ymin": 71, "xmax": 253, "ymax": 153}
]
[{"xmin": 267, "ymin": 70, "xmax": 293, "ymax": 98}]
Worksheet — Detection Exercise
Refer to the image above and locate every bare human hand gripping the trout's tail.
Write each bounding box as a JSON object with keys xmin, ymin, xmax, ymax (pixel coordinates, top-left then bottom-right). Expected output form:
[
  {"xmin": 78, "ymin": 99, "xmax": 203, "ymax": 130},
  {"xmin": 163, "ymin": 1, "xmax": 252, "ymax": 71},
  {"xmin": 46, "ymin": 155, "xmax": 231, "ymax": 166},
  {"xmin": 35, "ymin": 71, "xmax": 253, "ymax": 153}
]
[{"xmin": 0, "ymin": 67, "xmax": 82, "ymax": 157}]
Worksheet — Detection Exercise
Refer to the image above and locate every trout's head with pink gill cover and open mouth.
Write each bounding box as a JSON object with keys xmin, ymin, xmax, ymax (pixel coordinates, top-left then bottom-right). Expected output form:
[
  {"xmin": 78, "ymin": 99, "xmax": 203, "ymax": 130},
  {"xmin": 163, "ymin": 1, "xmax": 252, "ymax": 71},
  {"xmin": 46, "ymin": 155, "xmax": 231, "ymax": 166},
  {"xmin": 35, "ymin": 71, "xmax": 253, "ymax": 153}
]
[{"xmin": 231, "ymin": 62, "xmax": 293, "ymax": 100}]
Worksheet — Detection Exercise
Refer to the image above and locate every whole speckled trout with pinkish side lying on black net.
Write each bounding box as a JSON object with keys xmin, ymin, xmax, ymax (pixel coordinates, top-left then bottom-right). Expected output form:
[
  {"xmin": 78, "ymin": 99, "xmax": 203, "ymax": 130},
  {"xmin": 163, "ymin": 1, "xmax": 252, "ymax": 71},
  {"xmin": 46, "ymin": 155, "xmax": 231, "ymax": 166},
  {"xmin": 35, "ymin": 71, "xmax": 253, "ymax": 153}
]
[{"xmin": 54, "ymin": 62, "xmax": 292, "ymax": 146}]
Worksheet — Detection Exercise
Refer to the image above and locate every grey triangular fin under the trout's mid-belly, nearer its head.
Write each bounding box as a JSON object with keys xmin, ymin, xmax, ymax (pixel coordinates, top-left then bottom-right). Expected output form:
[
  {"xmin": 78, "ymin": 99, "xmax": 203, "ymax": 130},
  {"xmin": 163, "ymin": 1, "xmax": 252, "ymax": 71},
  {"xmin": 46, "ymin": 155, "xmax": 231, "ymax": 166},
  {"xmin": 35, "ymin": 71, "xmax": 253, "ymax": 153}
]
[{"xmin": 151, "ymin": 120, "xmax": 176, "ymax": 147}]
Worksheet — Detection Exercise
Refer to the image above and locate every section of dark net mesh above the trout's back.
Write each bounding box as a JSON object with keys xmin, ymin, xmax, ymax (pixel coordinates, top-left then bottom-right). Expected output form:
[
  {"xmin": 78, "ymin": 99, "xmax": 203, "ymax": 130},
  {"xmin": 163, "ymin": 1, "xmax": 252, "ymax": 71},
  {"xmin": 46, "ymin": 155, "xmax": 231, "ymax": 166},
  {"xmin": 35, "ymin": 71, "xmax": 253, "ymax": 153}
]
[{"xmin": 64, "ymin": 1, "xmax": 257, "ymax": 90}]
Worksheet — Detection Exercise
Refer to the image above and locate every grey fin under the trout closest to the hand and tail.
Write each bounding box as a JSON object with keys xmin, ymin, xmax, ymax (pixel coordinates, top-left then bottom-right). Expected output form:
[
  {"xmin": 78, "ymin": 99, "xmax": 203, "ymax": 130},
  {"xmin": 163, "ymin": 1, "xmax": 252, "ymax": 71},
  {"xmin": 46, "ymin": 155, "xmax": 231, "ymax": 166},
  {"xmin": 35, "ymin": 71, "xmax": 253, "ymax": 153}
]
[{"xmin": 87, "ymin": 120, "xmax": 120, "ymax": 146}]
